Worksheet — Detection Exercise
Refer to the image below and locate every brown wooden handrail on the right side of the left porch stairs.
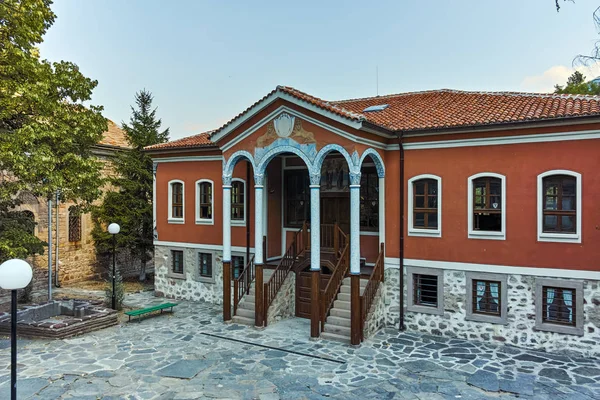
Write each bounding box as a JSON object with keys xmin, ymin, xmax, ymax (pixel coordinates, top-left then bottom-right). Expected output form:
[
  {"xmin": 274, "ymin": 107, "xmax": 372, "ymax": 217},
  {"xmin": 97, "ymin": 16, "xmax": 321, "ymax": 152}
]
[{"xmin": 264, "ymin": 222, "xmax": 308, "ymax": 326}]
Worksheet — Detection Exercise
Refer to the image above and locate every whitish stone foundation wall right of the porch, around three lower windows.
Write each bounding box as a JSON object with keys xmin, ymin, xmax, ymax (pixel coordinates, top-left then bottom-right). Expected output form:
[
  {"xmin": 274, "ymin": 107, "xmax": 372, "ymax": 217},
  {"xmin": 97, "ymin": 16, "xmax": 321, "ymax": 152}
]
[{"xmin": 384, "ymin": 268, "xmax": 600, "ymax": 357}]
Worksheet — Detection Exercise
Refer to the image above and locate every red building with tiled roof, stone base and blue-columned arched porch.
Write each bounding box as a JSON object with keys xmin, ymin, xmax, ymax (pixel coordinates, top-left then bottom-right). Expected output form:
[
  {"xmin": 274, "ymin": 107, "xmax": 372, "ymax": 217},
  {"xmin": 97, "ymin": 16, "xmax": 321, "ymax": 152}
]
[{"xmin": 147, "ymin": 86, "xmax": 600, "ymax": 355}]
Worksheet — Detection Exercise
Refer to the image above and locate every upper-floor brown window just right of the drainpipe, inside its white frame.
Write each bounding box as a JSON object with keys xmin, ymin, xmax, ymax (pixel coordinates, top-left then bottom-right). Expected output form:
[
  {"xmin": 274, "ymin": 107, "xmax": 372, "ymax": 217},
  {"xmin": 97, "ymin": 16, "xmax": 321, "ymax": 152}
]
[{"xmin": 413, "ymin": 179, "xmax": 438, "ymax": 229}]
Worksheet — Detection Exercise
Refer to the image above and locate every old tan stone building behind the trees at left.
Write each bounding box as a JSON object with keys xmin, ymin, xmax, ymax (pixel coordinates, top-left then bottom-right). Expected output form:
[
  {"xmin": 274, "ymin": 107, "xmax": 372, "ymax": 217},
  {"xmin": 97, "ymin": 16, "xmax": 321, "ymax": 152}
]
[{"xmin": 4, "ymin": 120, "xmax": 136, "ymax": 299}]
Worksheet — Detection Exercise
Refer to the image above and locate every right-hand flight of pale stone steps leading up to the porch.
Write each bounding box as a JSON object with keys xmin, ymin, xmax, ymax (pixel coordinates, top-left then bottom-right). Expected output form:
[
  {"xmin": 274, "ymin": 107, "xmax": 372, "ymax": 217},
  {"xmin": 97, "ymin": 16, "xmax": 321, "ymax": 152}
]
[{"xmin": 321, "ymin": 277, "xmax": 369, "ymax": 343}]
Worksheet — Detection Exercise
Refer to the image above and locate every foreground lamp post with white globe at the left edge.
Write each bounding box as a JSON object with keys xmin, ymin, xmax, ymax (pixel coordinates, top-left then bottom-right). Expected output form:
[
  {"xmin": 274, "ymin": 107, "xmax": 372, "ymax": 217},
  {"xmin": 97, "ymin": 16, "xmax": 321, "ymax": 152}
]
[{"xmin": 0, "ymin": 259, "xmax": 33, "ymax": 400}]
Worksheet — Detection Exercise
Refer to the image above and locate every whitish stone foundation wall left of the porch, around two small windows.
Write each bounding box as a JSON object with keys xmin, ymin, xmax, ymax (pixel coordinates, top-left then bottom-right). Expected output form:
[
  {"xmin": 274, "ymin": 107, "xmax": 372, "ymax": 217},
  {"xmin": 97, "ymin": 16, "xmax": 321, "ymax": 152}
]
[{"xmin": 154, "ymin": 246, "xmax": 223, "ymax": 304}]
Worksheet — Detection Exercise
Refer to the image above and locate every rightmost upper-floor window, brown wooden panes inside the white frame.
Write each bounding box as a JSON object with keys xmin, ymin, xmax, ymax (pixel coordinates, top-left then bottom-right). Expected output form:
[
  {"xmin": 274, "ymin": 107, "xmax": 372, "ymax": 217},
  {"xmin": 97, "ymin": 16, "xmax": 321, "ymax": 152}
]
[{"xmin": 543, "ymin": 175, "xmax": 577, "ymax": 233}]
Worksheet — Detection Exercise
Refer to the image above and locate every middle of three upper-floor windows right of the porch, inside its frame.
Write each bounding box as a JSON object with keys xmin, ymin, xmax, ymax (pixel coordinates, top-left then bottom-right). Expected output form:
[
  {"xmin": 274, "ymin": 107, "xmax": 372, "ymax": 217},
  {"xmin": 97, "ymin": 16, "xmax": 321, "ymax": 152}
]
[{"xmin": 473, "ymin": 177, "xmax": 503, "ymax": 232}]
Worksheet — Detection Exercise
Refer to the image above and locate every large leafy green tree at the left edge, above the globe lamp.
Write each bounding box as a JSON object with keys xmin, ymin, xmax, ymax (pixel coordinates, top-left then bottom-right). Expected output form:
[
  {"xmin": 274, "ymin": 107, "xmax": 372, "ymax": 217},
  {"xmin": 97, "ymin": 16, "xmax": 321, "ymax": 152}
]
[{"xmin": 0, "ymin": 0, "xmax": 107, "ymax": 257}]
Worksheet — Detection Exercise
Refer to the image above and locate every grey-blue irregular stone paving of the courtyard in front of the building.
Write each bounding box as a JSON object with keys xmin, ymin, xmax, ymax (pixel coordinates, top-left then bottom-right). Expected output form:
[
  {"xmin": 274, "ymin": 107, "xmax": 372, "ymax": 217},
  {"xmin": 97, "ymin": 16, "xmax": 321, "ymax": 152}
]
[{"xmin": 0, "ymin": 292, "xmax": 600, "ymax": 400}]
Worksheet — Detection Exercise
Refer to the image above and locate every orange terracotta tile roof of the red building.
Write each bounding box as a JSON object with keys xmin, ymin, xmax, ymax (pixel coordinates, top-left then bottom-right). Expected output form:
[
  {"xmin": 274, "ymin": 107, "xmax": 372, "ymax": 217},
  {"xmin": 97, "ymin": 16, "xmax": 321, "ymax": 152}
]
[{"xmin": 146, "ymin": 86, "xmax": 600, "ymax": 150}]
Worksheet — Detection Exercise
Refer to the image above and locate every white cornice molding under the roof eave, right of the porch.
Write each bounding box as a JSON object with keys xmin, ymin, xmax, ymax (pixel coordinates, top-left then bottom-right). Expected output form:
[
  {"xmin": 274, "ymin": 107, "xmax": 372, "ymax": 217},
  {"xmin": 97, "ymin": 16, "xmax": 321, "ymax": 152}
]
[{"xmin": 403, "ymin": 130, "xmax": 600, "ymax": 150}]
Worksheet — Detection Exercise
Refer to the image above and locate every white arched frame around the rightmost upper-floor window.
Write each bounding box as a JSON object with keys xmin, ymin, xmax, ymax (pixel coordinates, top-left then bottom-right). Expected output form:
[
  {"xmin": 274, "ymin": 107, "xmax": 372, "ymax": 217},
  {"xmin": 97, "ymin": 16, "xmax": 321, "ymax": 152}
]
[{"xmin": 537, "ymin": 169, "xmax": 583, "ymax": 243}]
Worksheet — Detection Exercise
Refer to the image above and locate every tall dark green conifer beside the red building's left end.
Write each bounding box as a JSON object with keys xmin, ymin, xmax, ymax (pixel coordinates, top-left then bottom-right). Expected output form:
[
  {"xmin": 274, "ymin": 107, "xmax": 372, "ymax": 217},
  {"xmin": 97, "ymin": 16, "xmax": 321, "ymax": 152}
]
[{"xmin": 92, "ymin": 90, "xmax": 169, "ymax": 281}]
